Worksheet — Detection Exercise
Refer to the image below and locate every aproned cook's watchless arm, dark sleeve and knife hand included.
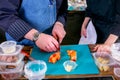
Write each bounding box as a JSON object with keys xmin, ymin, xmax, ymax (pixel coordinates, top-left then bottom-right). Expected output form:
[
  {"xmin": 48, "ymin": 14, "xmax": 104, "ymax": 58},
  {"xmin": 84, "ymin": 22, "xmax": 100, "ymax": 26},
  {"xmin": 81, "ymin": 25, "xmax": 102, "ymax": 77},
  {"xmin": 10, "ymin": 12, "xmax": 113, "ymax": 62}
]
[{"xmin": 52, "ymin": 0, "xmax": 68, "ymax": 43}]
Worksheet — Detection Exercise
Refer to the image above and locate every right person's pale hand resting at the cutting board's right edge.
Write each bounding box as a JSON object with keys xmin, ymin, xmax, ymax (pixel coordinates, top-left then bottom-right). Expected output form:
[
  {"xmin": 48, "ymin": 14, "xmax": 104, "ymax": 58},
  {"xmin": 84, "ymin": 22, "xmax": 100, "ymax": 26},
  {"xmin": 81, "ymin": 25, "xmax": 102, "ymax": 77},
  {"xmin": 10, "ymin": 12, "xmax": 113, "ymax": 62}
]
[{"xmin": 93, "ymin": 44, "xmax": 111, "ymax": 53}]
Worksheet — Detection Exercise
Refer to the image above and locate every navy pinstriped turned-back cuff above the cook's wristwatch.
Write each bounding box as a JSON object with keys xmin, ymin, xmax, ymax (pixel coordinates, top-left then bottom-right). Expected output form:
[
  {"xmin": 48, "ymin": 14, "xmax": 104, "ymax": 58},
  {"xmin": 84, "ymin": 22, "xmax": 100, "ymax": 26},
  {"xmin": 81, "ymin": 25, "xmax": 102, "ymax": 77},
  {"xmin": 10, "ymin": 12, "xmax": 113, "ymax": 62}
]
[{"xmin": 7, "ymin": 19, "xmax": 32, "ymax": 41}]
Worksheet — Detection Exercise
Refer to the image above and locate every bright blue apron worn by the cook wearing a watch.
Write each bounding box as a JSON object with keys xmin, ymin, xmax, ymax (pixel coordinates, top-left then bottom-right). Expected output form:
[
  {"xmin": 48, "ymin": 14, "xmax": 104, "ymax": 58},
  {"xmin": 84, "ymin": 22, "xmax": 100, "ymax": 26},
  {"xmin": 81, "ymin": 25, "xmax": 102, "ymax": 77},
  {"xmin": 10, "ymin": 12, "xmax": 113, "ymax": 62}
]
[{"xmin": 6, "ymin": 0, "xmax": 56, "ymax": 46}]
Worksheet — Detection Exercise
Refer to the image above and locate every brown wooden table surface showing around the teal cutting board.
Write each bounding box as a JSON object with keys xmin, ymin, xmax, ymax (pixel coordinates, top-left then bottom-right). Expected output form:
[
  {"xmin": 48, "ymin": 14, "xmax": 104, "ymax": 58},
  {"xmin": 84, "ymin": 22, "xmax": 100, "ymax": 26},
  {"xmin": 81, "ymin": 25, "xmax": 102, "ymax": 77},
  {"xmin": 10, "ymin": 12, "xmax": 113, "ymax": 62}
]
[{"xmin": 0, "ymin": 44, "xmax": 119, "ymax": 80}]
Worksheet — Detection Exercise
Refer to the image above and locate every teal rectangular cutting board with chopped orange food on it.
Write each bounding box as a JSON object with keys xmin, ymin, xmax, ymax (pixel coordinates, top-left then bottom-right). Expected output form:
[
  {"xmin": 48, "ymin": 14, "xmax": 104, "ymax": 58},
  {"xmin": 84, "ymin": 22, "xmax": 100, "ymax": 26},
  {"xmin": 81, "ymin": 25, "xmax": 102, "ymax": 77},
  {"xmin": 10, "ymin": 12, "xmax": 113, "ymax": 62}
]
[{"xmin": 31, "ymin": 45, "xmax": 99, "ymax": 75}]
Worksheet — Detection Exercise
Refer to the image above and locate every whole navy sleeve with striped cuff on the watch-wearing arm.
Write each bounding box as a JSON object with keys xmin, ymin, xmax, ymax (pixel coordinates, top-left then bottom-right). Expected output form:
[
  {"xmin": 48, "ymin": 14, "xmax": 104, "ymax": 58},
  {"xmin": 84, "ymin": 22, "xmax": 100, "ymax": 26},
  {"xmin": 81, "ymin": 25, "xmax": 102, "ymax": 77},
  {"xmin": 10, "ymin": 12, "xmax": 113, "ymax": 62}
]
[{"xmin": 0, "ymin": 0, "xmax": 32, "ymax": 41}]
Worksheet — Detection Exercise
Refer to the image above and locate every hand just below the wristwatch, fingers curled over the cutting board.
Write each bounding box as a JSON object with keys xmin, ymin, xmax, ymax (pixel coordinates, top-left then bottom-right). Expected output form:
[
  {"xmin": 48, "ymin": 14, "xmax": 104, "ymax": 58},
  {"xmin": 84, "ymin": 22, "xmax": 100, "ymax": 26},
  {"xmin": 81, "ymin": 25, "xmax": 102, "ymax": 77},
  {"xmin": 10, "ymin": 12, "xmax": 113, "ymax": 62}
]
[{"xmin": 35, "ymin": 33, "xmax": 59, "ymax": 52}]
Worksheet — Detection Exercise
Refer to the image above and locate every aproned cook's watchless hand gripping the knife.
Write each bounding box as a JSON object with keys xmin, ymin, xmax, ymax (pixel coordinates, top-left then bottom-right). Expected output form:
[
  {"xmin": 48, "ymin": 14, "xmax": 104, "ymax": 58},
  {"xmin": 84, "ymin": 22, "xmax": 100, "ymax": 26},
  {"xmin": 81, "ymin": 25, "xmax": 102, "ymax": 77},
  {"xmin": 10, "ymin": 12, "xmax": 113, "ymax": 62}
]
[{"xmin": 52, "ymin": 22, "xmax": 66, "ymax": 43}]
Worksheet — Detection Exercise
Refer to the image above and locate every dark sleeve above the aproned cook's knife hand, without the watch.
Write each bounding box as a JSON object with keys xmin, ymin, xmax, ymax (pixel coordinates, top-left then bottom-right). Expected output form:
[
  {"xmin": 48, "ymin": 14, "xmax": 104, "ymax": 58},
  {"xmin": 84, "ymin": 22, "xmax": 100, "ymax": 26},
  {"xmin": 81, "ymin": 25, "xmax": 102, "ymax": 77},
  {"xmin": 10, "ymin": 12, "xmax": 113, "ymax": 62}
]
[{"xmin": 57, "ymin": 0, "xmax": 68, "ymax": 26}]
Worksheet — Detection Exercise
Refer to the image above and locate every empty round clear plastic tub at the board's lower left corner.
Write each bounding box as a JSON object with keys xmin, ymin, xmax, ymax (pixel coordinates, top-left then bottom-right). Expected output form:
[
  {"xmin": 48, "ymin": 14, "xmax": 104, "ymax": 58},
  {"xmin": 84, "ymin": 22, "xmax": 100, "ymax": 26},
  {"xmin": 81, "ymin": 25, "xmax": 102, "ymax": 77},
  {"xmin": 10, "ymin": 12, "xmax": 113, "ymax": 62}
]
[{"xmin": 24, "ymin": 60, "xmax": 47, "ymax": 80}]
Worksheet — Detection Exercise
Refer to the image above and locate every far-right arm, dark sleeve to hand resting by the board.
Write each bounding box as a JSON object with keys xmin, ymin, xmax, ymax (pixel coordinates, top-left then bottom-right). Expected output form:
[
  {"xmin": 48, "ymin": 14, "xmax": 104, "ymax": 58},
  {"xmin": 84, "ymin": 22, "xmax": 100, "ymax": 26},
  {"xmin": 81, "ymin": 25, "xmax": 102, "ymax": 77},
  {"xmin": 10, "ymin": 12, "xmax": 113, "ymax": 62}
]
[{"xmin": 94, "ymin": 0, "xmax": 120, "ymax": 52}]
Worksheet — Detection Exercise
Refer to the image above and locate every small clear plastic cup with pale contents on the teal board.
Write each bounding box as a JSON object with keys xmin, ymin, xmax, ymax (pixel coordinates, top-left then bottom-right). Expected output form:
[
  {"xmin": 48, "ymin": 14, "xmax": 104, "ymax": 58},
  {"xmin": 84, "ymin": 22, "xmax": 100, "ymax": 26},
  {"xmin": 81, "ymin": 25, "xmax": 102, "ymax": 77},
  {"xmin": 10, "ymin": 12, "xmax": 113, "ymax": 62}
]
[{"xmin": 63, "ymin": 60, "xmax": 77, "ymax": 72}]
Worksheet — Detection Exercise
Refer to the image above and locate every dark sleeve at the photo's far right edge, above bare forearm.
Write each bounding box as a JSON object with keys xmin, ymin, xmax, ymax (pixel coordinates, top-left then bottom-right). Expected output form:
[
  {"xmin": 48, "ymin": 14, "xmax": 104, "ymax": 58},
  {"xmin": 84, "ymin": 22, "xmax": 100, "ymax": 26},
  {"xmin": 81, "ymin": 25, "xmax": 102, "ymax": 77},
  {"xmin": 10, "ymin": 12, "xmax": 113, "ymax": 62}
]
[{"xmin": 111, "ymin": 0, "xmax": 120, "ymax": 37}]
